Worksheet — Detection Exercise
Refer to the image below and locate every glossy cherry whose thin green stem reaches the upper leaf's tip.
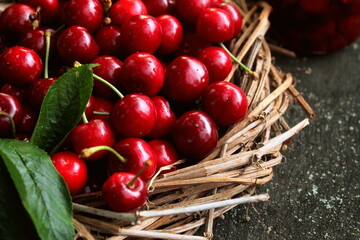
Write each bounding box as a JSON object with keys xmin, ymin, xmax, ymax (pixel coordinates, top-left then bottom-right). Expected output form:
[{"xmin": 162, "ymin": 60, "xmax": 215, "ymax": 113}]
[{"xmin": 110, "ymin": 93, "xmax": 156, "ymax": 137}]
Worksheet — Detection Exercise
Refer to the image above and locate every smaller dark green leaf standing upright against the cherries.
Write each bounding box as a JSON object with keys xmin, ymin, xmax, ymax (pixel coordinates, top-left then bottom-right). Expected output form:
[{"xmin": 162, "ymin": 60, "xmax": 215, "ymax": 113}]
[{"xmin": 30, "ymin": 64, "xmax": 93, "ymax": 152}]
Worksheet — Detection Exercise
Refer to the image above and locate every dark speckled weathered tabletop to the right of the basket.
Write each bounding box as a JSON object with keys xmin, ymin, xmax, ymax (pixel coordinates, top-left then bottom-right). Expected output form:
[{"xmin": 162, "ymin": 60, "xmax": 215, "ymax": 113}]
[{"xmin": 214, "ymin": 39, "xmax": 360, "ymax": 240}]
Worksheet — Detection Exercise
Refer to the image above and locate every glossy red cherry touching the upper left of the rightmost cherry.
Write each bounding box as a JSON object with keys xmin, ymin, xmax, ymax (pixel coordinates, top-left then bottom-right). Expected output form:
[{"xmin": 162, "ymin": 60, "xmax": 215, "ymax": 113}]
[{"xmin": 163, "ymin": 56, "xmax": 209, "ymax": 102}]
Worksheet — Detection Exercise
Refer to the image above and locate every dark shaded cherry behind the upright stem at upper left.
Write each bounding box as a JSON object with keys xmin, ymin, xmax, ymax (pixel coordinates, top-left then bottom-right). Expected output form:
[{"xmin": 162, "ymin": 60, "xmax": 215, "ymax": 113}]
[{"xmin": 20, "ymin": 28, "xmax": 55, "ymax": 58}]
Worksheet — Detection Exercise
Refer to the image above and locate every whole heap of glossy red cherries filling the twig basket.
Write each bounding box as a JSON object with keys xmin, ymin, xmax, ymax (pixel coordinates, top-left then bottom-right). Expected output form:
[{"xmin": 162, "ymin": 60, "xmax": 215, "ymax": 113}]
[{"xmin": 0, "ymin": 0, "xmax": 248, "ymax": 211}]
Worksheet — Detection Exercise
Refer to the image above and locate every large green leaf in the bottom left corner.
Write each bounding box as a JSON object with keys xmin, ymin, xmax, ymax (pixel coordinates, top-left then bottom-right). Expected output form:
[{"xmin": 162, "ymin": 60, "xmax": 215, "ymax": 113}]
[{"xmin": 0, "ymin": 139, "xmax": 75, "ymax": 240}]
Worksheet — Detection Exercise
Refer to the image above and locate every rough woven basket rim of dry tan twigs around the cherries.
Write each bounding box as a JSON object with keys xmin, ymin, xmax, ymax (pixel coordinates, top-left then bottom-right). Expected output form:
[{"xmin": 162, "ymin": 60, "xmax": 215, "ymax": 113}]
[{"xmin": 0, "ymin": 1, "xmax": 315, "ymax": 240}]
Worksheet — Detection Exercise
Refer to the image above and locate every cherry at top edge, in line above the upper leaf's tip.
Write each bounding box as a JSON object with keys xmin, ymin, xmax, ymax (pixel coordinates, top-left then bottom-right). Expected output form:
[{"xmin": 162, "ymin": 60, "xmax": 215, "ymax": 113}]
[{"xmin": 63, "ymin": 0, "xmax": 104, "ymax": 33}]
